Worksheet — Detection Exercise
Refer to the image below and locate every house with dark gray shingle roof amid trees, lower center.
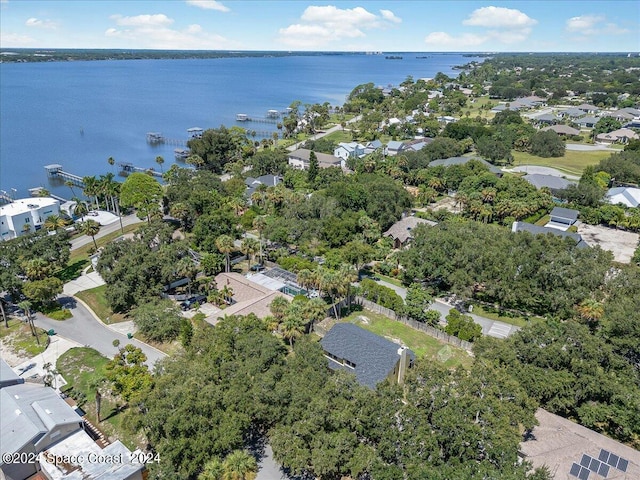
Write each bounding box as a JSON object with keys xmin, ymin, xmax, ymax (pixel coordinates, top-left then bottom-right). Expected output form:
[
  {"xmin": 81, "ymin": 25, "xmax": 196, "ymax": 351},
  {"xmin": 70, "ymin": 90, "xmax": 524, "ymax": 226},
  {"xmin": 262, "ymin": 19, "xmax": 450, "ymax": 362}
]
[{"xmin": 320, "ymin": 323, "xmax": 416, "ymax": 389}]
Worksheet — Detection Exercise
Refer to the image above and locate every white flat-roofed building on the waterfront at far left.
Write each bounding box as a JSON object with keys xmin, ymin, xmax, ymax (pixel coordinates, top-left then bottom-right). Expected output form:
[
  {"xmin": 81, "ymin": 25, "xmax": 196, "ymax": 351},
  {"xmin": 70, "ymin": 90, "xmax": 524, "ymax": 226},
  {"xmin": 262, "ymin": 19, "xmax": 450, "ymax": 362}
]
[{"xmin": 0, "ymin": 197, "xmax": 60, "ymax": 240}]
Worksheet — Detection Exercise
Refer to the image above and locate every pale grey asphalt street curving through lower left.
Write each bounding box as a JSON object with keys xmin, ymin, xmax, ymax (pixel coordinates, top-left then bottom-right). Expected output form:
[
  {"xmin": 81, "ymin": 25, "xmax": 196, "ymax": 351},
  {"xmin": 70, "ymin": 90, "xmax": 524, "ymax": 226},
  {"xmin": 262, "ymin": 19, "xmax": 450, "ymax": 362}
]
[{"xmin": 35, "ymin": 296, "xmax": 167, "ymax": 367}]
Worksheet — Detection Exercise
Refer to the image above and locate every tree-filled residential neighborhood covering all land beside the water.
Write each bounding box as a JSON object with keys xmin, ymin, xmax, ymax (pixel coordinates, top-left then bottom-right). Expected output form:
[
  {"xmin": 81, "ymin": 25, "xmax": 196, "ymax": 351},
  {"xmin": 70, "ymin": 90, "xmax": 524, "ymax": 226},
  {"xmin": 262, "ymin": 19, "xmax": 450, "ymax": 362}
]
[{"xmin": 0, "ymin": 47, "xmax": 640, "ymax": 480}]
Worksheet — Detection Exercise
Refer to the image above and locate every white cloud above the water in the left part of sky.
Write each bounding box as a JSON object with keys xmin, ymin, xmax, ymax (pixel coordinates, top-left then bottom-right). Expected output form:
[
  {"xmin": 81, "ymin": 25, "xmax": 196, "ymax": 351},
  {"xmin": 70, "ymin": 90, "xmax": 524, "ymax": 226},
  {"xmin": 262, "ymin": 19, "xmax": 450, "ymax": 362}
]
[{"xmin": 104, "ymin": 14, "xmax": 241, "ymax": 50}]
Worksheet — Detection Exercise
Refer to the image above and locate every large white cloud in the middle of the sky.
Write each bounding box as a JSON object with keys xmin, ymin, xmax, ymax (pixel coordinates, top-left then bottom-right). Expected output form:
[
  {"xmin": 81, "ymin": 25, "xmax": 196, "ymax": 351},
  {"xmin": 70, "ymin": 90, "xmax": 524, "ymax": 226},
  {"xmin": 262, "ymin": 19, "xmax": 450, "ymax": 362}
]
[{"xmin": 278, "ymin": 5, "xmax": 402, "ymax": 48}]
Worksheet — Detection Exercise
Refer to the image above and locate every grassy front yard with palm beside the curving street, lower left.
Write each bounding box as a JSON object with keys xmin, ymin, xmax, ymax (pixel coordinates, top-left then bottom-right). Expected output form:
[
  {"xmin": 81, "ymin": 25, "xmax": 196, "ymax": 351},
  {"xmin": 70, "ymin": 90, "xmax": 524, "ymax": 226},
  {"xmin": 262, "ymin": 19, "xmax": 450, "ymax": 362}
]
[{"xmin": 56, "ymin": 347, "xmax": 144, "ymax": 450}]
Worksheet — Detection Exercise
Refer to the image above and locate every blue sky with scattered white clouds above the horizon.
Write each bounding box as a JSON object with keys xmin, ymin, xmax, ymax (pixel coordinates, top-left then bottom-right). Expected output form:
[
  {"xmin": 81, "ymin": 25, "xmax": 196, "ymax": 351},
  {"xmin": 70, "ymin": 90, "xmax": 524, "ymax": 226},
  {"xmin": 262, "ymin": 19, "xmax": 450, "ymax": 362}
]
[{"xmin": 0, "ymin": 0, "xmax": 640, "ymax": 52}]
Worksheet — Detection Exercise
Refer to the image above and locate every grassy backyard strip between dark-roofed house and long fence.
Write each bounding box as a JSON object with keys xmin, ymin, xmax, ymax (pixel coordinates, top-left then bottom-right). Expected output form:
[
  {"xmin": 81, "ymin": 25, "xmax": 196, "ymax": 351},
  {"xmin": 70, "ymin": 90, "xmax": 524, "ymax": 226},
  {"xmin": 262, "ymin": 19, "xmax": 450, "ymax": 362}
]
[{"xmin": 340, "ymin": 310, "xmax": 473, "ymax": 368}]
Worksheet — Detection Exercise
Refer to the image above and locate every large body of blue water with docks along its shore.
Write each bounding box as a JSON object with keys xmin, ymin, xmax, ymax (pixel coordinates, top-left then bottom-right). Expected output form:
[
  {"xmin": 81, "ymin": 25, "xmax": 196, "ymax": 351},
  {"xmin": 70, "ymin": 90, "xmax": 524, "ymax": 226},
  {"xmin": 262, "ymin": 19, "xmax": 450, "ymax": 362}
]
[{"xmin": 0, "ymin": 53, "xmax": 470, "ymax": 198}]
